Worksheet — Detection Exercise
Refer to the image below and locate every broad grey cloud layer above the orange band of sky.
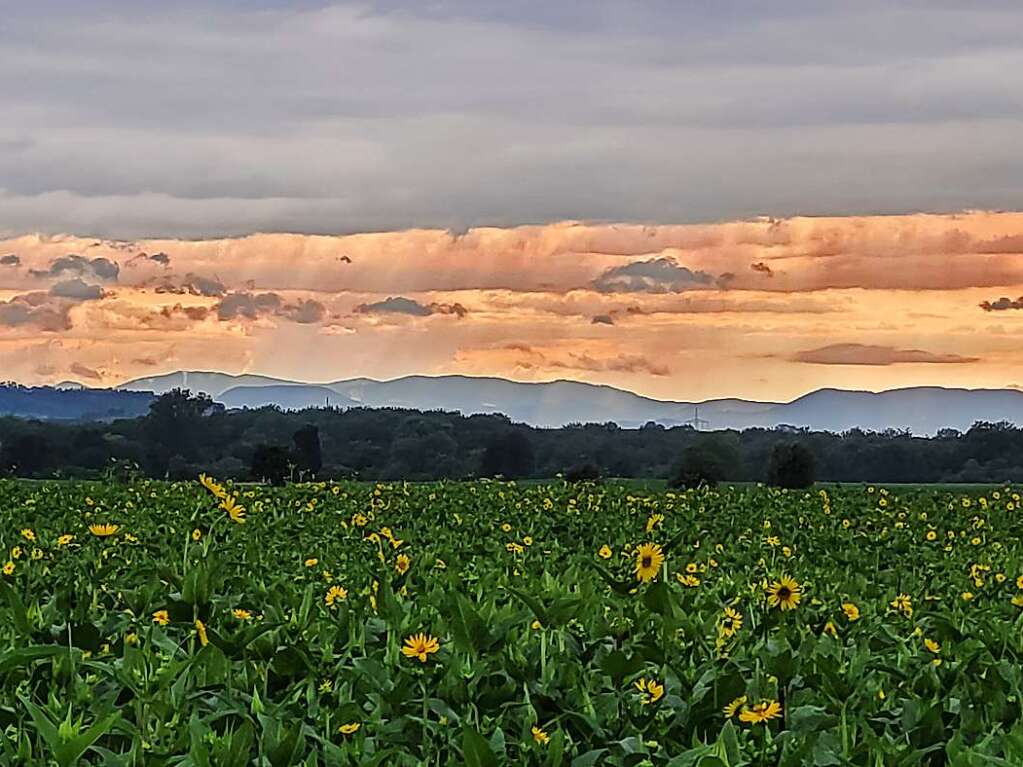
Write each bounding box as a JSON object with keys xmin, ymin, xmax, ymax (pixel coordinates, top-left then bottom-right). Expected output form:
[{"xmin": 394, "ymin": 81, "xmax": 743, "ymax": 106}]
[{"xmin": 0, "ymin": 0, "xmax": 1023, "ymax": 237}]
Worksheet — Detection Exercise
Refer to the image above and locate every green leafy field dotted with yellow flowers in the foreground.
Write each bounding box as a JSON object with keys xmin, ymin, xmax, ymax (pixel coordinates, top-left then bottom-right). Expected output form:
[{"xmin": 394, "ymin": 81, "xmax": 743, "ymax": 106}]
[{"xmin": 0, "ymin": 477, "xmax": 1023, "ymax": 767}]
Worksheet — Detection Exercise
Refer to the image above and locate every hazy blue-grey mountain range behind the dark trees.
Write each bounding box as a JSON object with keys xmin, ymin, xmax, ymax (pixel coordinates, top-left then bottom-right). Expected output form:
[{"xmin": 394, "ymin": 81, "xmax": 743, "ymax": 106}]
[{"xmin": 97, "ymin": 371, "xmax": 1023, "ymax": 435}]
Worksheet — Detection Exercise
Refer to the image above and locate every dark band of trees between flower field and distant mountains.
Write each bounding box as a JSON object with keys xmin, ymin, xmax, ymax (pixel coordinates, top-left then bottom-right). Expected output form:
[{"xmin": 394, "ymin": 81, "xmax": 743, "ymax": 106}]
[{"xmin": 0, "ymin": 390, "xmax": 1023, "ymax": 485}]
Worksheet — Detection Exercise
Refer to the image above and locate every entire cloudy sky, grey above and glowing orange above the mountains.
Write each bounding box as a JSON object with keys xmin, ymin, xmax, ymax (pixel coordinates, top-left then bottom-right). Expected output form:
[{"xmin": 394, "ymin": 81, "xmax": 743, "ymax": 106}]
[{"xmin": 0, "ymin": 0, "xmax": 1023, "ymax": 399}]
